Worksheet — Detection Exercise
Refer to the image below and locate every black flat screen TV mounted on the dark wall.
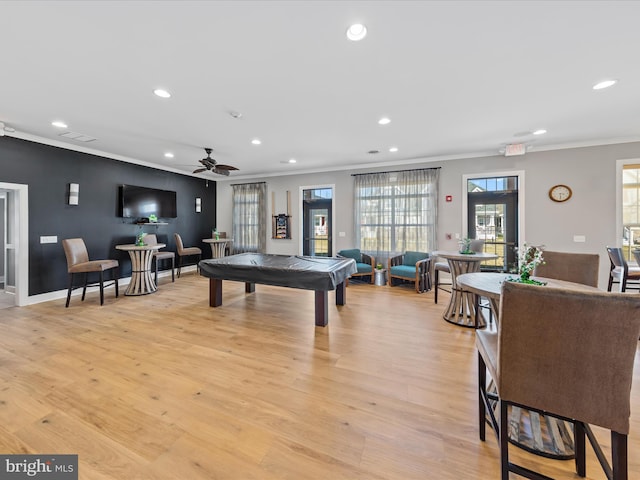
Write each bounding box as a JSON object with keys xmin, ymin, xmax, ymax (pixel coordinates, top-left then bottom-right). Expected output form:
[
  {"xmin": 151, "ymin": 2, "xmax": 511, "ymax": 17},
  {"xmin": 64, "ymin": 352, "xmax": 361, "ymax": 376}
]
[{"xmin": 120, "ymin": 185, "xmax": 178, "ymax": 219}]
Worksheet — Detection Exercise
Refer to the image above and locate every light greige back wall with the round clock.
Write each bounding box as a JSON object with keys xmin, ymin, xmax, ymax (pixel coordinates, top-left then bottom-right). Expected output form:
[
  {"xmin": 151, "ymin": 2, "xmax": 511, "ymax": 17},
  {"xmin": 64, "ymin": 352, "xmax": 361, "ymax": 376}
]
[{"xmin": 217, "ymin": 142, "xmax": 640, "ymax": 287}]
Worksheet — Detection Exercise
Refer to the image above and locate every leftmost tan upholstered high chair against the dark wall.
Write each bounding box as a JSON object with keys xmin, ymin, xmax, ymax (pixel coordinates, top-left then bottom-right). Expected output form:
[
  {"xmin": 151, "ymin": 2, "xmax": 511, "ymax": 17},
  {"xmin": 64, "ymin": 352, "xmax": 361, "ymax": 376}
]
[{"xmin": 62, "ymin": 238, "xmax": 120, "ymax": 307}]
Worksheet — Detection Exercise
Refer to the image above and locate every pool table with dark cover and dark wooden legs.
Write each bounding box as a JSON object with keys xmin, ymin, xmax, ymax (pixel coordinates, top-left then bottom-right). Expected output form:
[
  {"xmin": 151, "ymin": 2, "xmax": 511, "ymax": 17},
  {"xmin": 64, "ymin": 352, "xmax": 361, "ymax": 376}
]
[{"xmin": 198, "ymin": 253, "xmax": 357, "ymax": 327}]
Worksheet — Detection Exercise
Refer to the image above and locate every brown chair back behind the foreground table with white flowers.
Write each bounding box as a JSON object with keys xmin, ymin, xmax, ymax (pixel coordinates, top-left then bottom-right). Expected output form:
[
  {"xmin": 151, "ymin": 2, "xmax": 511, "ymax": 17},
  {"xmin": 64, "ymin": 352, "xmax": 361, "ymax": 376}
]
[{"xmin": 533, "ymin": 250, "xmax": 600, "ymax": 288}]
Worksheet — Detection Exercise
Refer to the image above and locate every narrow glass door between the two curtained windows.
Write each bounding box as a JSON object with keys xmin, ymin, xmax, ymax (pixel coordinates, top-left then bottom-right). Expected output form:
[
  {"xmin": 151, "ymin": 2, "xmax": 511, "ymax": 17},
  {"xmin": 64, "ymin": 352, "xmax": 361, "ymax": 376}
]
[{"xmin": 301, "ymin": 186, "xmax": 333, "ymax": 257}]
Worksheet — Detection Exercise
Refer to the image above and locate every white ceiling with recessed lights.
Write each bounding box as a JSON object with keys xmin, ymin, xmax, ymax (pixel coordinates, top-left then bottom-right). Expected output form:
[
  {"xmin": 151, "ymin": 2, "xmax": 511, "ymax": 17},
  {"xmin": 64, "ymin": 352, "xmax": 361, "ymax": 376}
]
[{"xmin": 0, "ymin": 0, "xmax": 640, "ymax": 180}]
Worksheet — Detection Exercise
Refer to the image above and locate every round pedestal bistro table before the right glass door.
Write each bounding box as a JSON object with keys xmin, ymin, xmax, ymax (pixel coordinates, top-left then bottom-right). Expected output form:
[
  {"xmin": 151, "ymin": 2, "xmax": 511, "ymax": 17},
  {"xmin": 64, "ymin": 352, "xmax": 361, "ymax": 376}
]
[{"xmin": 432, "ymin": 250, "xmax": 498, "ymax": 328}]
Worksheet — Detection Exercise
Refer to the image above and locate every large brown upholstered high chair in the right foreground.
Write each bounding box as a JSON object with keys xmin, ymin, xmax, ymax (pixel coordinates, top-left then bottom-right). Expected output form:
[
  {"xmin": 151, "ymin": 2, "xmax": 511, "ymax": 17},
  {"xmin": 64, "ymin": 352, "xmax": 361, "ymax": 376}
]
[{"xmin": 476, "ymin": 282, "xmax": 640, "ymax": 480}]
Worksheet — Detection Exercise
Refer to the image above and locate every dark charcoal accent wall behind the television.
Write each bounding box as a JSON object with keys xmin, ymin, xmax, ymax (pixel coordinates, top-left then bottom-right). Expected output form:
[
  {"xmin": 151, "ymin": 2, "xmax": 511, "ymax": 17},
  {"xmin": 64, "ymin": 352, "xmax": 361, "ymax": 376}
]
[{"xmin": 0, "ymin": 136, "xmax": 216, "ymax": 295}]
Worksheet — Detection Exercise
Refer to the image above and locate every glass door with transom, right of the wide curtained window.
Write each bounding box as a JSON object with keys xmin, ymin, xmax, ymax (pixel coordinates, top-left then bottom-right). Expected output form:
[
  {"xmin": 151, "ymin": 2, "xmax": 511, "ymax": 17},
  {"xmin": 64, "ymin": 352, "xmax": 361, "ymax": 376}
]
[{"xmin": 465, "ymin": 175, "xmax": 522, "ymax": 272}]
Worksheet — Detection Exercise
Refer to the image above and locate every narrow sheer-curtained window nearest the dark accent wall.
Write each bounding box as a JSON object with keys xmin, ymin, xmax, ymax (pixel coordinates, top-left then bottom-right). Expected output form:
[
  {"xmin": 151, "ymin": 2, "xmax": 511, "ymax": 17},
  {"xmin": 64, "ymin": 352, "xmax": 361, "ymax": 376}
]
[{"xmin": 232, "ymin": 182, "xmax": 267, "ymax": 253}]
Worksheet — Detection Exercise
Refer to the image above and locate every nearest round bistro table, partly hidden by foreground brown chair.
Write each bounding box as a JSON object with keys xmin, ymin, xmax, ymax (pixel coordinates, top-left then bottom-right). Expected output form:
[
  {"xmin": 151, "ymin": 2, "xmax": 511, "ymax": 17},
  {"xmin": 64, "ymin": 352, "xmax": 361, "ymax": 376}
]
[{"xmin": 456, "ymin": 272, "xmax": 600, "ymax": 460}]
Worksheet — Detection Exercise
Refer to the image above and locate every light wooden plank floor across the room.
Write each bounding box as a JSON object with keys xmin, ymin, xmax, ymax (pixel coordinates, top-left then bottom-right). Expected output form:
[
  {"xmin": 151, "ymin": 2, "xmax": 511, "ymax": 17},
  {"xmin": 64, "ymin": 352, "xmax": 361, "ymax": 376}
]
[{"xmin": 0, "ymin": 273, "xmax": 640, "ymax": 480}]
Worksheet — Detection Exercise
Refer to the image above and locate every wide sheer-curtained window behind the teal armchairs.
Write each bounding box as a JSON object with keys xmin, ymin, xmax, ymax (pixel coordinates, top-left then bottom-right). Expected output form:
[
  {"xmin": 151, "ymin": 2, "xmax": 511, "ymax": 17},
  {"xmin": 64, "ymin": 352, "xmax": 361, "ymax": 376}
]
[{"xmin": 354, "ymin": 168, "xmax": 440, "ymax": 258}]
